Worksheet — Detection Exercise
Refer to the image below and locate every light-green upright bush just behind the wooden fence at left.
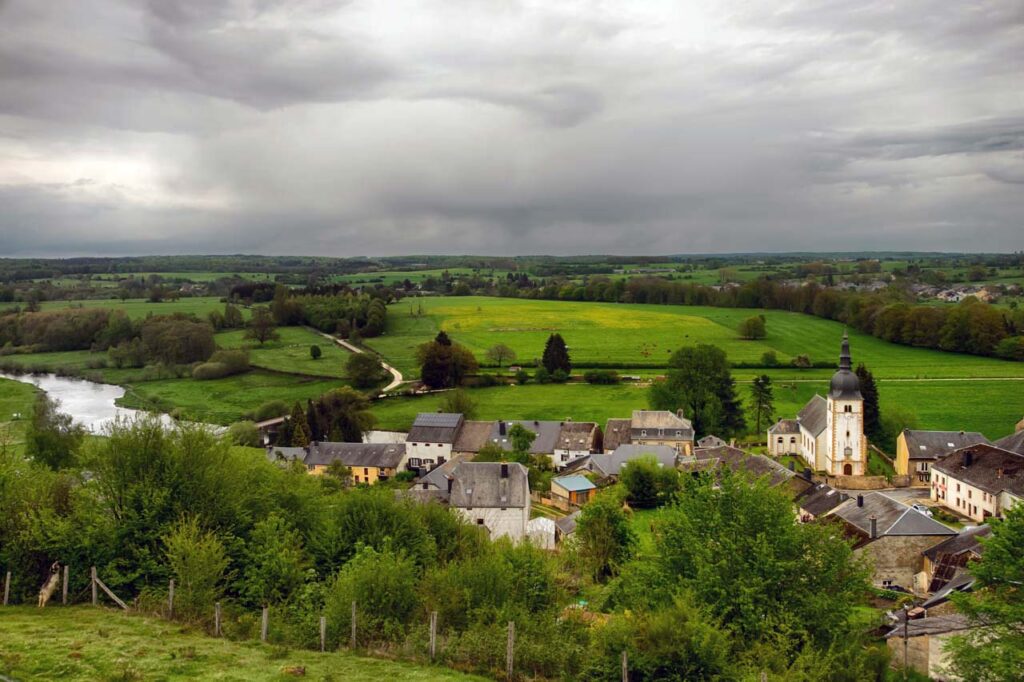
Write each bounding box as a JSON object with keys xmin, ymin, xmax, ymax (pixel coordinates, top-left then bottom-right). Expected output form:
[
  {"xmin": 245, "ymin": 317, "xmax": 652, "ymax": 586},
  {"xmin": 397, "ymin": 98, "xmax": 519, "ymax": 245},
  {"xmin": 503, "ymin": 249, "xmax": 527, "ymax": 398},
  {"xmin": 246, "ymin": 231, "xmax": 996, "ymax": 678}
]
[{"xmin": 163, "ymin": 516, "xmax": 228, "ymax": 620}]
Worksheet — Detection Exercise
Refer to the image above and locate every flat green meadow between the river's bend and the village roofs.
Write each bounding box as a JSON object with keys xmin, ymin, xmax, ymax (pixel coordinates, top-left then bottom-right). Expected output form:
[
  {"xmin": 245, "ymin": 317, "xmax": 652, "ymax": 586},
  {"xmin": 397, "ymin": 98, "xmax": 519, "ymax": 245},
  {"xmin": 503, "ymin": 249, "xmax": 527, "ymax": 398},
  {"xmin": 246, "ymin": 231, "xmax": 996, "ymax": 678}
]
[{"xmin": 119, "ymin": 370, "xmax": 344, "ymax": 424}]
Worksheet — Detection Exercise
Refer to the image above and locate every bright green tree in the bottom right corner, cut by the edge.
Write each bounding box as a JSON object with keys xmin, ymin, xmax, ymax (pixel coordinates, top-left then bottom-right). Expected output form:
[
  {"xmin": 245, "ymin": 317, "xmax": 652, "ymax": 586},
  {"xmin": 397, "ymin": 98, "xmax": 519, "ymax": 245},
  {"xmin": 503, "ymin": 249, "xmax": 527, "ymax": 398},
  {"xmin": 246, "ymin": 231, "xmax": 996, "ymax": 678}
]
[{"xmin": 946, "ymin": 505, "xmax": 1024, "ymax": 682}]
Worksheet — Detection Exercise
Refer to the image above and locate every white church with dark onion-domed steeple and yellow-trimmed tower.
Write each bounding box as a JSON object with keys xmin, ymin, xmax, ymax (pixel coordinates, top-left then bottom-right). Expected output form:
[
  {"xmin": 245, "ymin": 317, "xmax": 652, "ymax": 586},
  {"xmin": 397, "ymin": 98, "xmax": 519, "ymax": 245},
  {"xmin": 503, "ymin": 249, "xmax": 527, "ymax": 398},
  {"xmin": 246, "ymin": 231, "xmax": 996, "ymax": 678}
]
[{"xmin": 768, "ymin": 334, "xmax": 867, "ymax": 476}]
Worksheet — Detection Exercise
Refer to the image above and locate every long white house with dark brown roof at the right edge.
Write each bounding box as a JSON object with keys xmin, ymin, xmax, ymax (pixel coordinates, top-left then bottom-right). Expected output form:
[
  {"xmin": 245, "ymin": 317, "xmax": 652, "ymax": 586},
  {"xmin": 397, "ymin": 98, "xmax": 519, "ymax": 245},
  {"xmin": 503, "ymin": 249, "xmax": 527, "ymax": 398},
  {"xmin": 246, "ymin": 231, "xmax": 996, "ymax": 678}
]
[{"xmin": 931, "ymin": 443, "xmax": 1024, "ymax": 523}]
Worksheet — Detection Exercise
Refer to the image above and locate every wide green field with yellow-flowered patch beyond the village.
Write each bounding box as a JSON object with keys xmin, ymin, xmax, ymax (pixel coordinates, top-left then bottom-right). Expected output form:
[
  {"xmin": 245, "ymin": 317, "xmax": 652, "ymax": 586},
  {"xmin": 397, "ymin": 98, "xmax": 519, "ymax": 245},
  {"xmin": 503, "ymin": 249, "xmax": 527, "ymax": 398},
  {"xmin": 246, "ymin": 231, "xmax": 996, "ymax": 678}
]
[{"xmin": 366, "ymin": 296, "xmax": 1024, "ymax": 378}]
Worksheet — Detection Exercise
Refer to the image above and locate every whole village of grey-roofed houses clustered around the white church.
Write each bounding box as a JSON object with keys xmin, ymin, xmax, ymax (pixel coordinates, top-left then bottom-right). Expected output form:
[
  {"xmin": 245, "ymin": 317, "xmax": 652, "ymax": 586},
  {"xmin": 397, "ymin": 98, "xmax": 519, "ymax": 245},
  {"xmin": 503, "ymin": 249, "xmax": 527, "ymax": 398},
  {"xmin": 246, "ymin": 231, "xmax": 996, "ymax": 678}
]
[{"xmin": 266, "ymin": 336, "xmax": 1024, "ymax": 675}]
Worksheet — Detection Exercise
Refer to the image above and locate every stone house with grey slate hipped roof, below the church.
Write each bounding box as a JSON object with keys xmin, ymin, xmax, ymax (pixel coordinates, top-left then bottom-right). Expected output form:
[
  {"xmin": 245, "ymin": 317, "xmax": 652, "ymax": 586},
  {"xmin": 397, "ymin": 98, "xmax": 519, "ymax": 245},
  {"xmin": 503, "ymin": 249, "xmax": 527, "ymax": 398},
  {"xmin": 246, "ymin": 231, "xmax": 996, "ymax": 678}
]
[{"xmin": 818, "ymin": 493, "xmax": 956, "ymax": 590}]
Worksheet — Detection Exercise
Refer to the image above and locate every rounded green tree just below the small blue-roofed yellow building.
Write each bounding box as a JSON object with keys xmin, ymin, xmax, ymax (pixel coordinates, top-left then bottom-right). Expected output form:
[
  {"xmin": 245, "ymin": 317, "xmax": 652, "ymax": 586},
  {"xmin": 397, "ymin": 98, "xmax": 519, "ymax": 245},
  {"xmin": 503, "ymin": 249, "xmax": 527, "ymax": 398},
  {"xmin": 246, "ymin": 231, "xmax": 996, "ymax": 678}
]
[{"xmin": 575, "ymin": 494, "xmax": 637, "ymax": 582}]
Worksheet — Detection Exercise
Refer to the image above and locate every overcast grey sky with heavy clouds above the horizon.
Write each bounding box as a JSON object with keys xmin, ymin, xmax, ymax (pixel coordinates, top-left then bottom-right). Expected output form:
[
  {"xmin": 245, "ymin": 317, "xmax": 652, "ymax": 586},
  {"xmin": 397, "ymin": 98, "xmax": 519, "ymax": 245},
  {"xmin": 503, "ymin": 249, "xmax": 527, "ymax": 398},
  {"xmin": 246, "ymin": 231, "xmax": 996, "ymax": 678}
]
[{"xmin": 0, "ymin": 0, "xmax": 1024, "ymax": 256}]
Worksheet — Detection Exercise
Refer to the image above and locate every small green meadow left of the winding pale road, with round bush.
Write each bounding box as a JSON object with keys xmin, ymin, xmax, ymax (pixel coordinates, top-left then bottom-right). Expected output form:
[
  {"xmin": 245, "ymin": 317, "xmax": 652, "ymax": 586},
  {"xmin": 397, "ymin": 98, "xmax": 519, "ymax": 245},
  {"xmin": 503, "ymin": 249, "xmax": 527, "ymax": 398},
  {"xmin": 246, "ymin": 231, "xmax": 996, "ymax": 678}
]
[{"xmin": 216, "ymin": 327, "xmax": 351, "ymax": 379}]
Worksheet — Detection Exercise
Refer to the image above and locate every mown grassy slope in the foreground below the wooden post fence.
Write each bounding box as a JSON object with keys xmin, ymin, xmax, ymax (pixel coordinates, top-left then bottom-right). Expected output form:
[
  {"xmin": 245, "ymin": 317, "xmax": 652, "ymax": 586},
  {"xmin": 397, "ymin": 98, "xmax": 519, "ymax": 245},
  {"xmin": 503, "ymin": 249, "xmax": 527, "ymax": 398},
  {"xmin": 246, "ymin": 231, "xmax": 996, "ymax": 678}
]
[{"xmin": 0, "ymin": 606, "xmax": 482, "ymax": 682}]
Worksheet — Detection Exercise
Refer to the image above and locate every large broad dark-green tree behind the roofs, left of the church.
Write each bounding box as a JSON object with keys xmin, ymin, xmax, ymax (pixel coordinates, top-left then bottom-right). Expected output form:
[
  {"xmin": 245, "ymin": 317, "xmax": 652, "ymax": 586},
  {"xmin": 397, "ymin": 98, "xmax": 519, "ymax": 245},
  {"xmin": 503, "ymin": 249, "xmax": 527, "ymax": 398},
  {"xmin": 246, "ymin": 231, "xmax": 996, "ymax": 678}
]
[{"xmin": 648, "ymin": 344, "xmax": 746, "ymax": 436}]
